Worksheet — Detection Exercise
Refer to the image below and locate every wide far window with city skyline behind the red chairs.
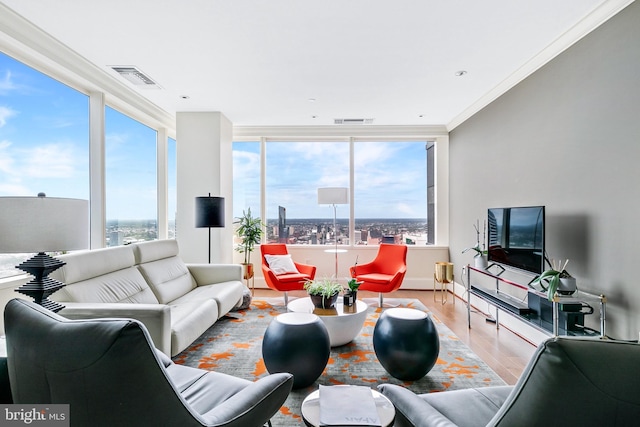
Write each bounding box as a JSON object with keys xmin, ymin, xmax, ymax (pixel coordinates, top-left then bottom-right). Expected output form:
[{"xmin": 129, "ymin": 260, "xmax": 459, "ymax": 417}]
[{"xmin": 233, "ymin": 139, "xmax": 433, "ymax": 245}]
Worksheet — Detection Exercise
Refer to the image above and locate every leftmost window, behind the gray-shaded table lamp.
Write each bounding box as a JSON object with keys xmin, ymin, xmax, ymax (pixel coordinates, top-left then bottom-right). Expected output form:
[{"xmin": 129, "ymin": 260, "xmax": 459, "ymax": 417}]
[{"xmin": 0, "ymin": 53, "xmax": 89, "ymax": 278}]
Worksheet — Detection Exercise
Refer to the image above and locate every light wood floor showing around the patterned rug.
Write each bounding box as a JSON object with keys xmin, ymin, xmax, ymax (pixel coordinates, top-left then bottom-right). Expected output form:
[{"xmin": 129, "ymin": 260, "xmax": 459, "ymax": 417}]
[{"xmin": 250, "ymin": 289, "xmax": 535, "ymax": 385}]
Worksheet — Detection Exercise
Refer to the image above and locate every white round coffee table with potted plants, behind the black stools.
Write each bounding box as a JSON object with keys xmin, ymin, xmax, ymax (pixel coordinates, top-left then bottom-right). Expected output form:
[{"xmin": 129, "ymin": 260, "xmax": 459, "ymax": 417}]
[{"xmin": 287, "ymin": 297, "xmax": 369, "ymax": 347}]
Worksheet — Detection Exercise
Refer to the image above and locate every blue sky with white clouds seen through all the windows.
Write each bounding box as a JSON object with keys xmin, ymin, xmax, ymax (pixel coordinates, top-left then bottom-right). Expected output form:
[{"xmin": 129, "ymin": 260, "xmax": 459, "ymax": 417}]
[{"xmin": 0, "ymin": 53, "xmax": 426, "ymax": 220}]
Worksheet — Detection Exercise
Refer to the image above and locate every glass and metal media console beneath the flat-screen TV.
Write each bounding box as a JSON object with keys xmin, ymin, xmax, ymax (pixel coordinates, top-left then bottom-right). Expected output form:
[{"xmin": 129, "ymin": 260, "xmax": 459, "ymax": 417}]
[{"xmin": 466, "ymin": 265, "xmax": 606, "ymax": 337}]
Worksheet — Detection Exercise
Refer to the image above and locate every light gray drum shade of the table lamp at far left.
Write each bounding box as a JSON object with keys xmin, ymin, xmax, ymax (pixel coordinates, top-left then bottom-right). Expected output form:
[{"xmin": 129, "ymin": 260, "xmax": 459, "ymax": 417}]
[{"xmin": 0, "ymin": 195, "xmax": 89, "ymax": 253}]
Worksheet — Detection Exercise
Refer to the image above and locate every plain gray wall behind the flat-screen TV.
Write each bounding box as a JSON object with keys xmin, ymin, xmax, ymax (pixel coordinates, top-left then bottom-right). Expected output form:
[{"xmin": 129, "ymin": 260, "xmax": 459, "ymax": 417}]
[{"xmin": 449, "ymin": 2, "xmax": 640, "ymax": 340}]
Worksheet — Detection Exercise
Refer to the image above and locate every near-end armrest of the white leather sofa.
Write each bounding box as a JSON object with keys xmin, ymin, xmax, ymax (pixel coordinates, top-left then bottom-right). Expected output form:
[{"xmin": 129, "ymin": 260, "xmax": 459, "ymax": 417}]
[{"xmin": 58, "ymin": 302, "xmax": 171, "ymax": 356}]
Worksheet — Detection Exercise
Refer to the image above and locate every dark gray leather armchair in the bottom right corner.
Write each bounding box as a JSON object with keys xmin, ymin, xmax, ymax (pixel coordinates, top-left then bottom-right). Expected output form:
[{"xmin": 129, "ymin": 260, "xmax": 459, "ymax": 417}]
[{"xmin": 378, "ymin": 337, "xmax": 640, "ymax": 427}]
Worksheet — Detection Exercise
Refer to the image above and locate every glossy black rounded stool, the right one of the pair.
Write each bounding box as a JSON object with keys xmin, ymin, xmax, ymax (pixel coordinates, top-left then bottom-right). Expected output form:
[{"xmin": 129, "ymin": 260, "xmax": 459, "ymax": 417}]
[{"xmin": 373, "ymin": 308, "xmax": 440, "ymax": 381}]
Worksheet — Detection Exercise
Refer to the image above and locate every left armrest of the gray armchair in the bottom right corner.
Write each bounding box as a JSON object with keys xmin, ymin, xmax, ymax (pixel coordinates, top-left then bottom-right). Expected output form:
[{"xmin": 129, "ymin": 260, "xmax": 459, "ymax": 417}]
[{"xmin": 378, "ymin": 384, "xmax": 455, "ymax": 427}]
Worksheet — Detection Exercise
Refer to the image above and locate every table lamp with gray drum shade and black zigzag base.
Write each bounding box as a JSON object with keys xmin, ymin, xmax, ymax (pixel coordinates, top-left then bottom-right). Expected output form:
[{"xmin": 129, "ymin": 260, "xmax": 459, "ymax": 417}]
[{"xmin": 0, "ymin": 193, "xmax": 89, "ymax": 312}]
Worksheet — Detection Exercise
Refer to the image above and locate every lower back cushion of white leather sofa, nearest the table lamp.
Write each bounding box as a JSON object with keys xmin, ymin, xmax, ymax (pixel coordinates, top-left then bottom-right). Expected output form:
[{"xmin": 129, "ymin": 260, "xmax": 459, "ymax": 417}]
[{"xmin": 51, "ymin": 266, "xmax": 158, "ymax": 304}]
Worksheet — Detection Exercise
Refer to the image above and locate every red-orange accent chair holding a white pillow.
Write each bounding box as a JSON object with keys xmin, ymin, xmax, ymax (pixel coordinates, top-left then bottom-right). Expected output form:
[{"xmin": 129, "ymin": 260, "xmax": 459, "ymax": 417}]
[{"xmin": 260, "ymin": 243, "xmax": 316, "ymax": 306}]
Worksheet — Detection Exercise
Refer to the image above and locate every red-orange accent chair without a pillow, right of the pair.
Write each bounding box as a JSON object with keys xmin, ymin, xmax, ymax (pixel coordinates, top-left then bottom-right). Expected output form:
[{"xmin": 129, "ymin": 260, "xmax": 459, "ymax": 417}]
[{"xmin": 349, "ymin": 243, "xmax": 407, "ymax": 307}]
